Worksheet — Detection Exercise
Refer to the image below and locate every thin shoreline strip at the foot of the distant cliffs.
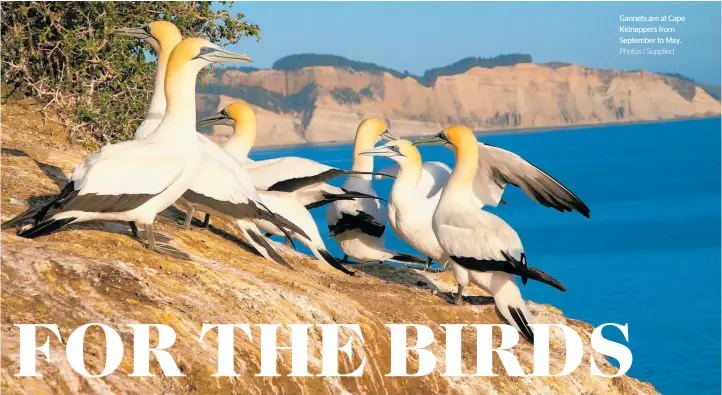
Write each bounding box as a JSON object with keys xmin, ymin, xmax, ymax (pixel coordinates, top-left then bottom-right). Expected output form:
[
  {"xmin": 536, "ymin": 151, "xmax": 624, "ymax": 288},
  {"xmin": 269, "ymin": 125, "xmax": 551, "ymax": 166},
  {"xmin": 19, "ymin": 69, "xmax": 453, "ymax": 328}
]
[{"xmin": 249, "ymin": 114, "xmax": 722, "ymax": 151}]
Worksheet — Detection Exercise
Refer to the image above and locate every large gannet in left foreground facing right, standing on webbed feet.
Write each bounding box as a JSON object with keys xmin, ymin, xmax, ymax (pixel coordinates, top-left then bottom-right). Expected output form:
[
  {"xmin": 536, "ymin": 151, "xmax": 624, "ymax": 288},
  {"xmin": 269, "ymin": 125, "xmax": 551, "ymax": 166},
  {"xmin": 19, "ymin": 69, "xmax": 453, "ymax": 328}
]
[{"xmin": 9, "ymin": 39, "xmax": 256, "ymax": 258}]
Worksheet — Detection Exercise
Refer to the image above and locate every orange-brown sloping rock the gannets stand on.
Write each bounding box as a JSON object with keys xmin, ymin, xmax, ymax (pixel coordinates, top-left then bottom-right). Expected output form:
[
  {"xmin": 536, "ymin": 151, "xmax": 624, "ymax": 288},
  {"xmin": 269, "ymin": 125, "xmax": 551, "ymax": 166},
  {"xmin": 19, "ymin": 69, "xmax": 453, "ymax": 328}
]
[{"xmin": 1, "ymin": 105, "xmax": 656, "ymax": 395}]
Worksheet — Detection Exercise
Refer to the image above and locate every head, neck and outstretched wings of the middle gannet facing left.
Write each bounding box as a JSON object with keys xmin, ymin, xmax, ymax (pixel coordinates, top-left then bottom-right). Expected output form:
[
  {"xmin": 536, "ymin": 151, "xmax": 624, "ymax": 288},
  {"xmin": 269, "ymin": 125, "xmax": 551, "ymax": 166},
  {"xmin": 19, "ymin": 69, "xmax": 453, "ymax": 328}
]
[{"xmin": 198, "ymin": 101, "xmax": 386, "ymax": 213}]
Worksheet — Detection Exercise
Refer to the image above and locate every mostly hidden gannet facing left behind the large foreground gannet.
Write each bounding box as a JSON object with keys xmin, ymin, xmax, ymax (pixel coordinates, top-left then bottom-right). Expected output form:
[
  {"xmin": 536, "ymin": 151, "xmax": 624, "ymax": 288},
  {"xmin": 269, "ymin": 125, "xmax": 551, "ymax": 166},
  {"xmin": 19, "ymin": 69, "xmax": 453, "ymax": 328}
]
[{"xmin": 3, "ymin": 21, "xmax": 183, "ymax": 232}]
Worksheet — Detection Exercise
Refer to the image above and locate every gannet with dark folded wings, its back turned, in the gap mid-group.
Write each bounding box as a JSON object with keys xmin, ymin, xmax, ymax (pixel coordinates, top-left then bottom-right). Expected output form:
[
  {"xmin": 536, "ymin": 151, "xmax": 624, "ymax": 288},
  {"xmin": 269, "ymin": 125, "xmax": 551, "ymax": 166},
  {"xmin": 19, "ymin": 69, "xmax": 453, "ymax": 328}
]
[{"xmin": 326, "ymin": 118, "xmax": 426, "ymax": 263}]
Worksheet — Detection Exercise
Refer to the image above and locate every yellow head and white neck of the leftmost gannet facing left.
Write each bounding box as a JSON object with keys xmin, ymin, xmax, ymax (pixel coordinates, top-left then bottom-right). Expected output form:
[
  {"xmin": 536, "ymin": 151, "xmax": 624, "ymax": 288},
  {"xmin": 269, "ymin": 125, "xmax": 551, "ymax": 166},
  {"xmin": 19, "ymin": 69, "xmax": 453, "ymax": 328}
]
[{"xmin": 113, "ymin": 21, "xmax": 183, "ymax": 140}]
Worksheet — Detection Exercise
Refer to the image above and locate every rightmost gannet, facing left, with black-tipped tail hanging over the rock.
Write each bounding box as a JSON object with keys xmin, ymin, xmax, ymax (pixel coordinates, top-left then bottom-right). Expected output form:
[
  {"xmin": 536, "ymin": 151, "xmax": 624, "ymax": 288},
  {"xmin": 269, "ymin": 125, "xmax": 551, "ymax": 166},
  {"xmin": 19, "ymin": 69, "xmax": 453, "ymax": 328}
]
[{"xmin": 416, "ymin": 126, "xmax": 572, "ymax": 343}]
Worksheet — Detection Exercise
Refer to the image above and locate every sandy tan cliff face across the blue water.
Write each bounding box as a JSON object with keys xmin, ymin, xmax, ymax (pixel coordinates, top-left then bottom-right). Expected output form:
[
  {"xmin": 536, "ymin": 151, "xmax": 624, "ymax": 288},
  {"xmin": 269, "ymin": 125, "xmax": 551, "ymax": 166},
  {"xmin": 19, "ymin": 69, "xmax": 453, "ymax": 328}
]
[{"xmin": 194, "ymin": 64, "xmax": 720, "ymax": 145}]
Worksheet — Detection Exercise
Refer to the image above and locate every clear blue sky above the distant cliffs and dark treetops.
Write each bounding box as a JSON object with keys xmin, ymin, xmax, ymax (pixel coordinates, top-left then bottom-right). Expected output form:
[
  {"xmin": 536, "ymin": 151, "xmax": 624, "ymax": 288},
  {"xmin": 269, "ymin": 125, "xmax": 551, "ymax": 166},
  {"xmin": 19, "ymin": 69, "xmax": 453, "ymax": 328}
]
[{"xmin": 222, "ymin": 1, "xmax": 722, "ymax": 84}]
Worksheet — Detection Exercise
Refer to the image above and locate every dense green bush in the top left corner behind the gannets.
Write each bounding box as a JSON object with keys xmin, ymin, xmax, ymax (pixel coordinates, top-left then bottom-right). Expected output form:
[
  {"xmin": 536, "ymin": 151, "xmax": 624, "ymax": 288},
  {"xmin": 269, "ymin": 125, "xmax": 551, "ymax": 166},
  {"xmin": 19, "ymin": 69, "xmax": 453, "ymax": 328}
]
[{"xmin": 0, "ymin": 1, "xmax": 259, "ymax": 148}]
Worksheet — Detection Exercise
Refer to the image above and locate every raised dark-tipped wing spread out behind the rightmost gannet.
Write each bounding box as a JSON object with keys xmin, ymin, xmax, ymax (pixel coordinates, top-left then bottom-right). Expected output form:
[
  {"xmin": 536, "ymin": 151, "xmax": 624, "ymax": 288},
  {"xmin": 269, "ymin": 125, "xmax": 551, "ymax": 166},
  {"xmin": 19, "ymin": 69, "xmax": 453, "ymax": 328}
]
[{"xmin": 473, "ymin": 143, "xmax": 590, "ymax": 218}]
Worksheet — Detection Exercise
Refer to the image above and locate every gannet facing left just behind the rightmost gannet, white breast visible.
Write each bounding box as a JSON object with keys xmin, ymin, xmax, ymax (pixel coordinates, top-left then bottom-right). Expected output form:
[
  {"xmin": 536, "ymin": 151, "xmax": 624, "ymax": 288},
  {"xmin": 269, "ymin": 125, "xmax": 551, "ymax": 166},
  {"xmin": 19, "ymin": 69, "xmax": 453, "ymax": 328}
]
[{"xmin": 361, "ymin": 139, "xmax": 451, "ymax": 268}]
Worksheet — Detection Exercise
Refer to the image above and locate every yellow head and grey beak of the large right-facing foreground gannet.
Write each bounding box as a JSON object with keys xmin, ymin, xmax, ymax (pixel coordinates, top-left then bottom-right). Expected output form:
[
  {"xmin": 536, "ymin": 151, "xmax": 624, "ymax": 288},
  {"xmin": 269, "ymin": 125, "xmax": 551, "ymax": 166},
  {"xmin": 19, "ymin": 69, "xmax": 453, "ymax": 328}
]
[{"xmin": 168, "ymin": 37, "xmax": 253, "ymax": 76}]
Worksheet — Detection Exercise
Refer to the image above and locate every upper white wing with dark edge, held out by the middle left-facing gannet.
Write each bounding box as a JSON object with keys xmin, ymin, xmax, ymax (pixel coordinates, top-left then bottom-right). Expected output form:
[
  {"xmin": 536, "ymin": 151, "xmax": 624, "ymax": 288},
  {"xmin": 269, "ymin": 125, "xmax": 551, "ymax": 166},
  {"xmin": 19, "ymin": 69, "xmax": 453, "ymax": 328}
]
[{"xmin": 247, "ymin": 156, "xmax": 346, "ymax": 192}]
